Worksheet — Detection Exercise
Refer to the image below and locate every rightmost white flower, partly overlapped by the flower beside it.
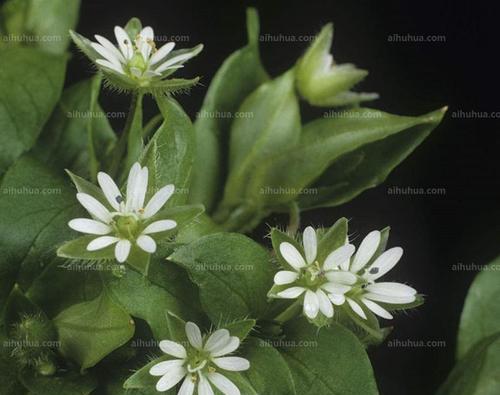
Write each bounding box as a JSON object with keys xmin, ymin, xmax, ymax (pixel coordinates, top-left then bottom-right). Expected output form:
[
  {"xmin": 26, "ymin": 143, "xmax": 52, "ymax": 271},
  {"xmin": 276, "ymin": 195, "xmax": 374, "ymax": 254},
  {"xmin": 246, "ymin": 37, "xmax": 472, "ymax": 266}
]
[{"xmin": 340, "ymin": 231, "xmax": 417, "ymax": 319}]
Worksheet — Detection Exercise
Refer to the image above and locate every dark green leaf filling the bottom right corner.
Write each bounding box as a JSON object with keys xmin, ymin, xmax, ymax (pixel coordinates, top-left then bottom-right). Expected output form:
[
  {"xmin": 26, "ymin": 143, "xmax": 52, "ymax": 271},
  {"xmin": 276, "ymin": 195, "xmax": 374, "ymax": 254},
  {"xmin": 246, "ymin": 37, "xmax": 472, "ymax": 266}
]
[{"xmin": 437, "ymin": 334, "xmax": 500, "ymax": 395}]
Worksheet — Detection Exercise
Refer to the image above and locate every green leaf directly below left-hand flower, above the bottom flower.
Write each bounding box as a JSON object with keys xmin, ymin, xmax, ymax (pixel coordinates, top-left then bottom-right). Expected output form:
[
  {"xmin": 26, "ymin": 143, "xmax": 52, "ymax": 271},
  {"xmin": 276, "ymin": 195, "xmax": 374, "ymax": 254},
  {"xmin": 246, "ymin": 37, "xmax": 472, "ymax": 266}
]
[{"xmin": 102, "ymin": 253, "xmax": 201, "ymax": 340}]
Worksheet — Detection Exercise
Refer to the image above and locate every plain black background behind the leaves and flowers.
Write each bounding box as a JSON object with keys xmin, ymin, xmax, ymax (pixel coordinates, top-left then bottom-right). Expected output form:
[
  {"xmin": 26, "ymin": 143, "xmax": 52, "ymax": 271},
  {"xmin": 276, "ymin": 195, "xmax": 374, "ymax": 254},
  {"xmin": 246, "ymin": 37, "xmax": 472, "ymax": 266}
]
[{"xmin": 68, "ymin": 0, "xmax": 500, "ymax": 395}]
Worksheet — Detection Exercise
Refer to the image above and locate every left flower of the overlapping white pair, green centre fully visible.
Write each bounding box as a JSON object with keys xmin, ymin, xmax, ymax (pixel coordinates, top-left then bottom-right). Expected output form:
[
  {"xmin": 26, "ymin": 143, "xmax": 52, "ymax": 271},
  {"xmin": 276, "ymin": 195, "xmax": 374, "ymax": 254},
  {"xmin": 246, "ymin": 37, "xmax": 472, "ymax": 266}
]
[{"xmin": 274, "ymin": 226, "xmax": 357, "ymax": 319}]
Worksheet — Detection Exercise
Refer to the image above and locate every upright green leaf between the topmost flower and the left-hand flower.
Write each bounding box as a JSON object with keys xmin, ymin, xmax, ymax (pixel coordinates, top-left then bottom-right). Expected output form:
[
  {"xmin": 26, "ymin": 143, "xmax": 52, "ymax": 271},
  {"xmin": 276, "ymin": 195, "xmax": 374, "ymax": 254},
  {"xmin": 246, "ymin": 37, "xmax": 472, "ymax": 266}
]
[{"xmin": 141, "ymin": 95, "xmax": 194, "ymax": 207}]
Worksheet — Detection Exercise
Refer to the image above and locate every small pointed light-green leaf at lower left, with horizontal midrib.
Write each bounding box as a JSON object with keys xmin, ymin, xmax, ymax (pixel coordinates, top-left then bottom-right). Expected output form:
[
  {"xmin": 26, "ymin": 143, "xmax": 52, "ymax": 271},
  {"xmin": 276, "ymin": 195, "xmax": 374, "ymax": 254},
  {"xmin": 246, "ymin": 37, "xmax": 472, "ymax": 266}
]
[{"xmin": 54, "ymin": 292, "xmax": 134, "ymax": 371}]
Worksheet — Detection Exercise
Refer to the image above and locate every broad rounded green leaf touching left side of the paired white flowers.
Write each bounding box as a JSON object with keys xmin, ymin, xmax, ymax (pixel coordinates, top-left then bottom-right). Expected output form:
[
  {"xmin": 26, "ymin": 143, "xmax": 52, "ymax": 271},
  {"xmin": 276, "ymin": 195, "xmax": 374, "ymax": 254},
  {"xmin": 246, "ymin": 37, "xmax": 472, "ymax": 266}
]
[{"xmin": 169, "ymin": 233, "xmax": 273, "ymax": 322}]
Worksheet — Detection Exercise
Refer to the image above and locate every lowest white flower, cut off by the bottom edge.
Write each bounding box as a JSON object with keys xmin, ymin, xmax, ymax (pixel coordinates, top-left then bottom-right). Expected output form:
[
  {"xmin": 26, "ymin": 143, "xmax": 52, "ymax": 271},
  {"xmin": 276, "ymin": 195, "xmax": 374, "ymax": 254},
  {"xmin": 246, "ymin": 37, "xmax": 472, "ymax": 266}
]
[{"xmin": 149, "ymin": 322, "xmax": 250, "ymax": 395}]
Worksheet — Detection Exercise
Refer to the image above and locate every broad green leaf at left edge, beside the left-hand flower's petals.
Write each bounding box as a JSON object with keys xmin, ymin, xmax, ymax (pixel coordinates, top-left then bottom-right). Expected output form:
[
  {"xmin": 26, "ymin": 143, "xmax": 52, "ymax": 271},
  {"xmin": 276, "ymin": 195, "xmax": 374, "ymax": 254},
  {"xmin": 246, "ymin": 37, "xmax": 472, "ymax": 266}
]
[{"xmin": 0, "ymin": 155, "xmax": 82, "ymax": 308}]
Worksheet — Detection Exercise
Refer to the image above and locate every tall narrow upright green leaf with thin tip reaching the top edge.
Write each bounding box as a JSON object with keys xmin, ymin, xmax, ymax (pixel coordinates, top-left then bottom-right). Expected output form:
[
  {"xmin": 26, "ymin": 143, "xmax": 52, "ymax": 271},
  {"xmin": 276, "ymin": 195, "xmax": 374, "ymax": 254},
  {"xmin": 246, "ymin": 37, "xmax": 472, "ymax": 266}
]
[{"xmin": 189, "ymin": 8, "xmax": 268, "ymax": 212}]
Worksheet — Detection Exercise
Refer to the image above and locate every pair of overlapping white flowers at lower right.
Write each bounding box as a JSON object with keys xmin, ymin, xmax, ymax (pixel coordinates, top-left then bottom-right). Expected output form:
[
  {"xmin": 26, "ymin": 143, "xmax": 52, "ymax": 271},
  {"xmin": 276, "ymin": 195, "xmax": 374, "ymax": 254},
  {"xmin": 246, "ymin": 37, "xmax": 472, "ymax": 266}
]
[{"xmin": 274, "ymin": 226, "xmax": 417, "ymax": 319}]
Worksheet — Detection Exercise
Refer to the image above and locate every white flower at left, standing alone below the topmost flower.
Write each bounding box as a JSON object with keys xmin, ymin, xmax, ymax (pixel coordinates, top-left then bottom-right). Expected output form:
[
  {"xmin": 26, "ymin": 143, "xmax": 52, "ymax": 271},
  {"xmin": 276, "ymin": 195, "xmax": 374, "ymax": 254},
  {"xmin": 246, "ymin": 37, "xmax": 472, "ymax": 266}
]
[{"xmin": 68, "ymin": 163, "xmax": 177, "ymax": 262}]
